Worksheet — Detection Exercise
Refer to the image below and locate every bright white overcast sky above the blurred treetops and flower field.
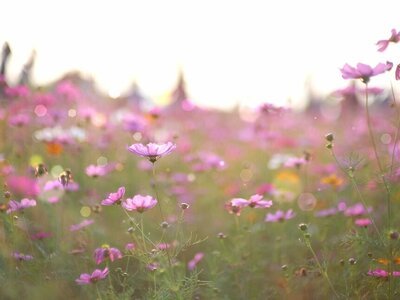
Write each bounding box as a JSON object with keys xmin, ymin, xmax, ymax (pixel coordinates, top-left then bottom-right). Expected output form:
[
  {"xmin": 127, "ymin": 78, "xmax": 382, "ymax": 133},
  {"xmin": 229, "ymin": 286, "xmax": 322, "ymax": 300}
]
[{"xmin": 0, "ymin": 0, "xmax": 400, "ymax": 107}]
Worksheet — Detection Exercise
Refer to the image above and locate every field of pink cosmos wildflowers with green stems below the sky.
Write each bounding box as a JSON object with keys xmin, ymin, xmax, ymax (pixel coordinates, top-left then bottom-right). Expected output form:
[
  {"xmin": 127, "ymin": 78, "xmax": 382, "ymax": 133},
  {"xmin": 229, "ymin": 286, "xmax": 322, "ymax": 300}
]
[{"xmin": 0, "ymin": 30, "xmax": 400, "ymax": 299}]
